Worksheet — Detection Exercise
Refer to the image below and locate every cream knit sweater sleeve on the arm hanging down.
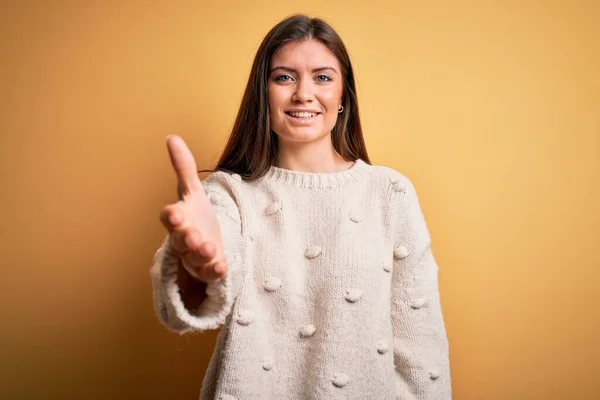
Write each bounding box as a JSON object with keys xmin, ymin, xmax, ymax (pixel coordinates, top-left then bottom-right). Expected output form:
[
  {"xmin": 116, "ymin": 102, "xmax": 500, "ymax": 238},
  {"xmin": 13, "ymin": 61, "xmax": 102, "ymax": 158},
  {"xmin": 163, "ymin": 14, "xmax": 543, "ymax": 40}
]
[{"xmin": 391, "ymin": 176, "xmax": 452, "ymax": 400}]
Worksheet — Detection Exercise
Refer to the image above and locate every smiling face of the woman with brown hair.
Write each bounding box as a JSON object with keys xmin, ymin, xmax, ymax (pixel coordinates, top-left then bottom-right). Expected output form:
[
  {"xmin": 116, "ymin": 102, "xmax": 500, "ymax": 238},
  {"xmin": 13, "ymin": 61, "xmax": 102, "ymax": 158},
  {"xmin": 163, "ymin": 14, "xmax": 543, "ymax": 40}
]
[{"xmin": 267, "ymin": 40, "xmax": 343, "ymax": 143}]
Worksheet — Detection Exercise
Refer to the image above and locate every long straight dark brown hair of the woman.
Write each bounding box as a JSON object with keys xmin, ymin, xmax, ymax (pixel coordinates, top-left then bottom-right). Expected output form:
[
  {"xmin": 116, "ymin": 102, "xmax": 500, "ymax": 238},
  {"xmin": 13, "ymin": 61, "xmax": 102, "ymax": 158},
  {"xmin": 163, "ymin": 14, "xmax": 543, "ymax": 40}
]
[{"xmin": 201, "ymin": 14, "xmax": 370, "ymax": 180}]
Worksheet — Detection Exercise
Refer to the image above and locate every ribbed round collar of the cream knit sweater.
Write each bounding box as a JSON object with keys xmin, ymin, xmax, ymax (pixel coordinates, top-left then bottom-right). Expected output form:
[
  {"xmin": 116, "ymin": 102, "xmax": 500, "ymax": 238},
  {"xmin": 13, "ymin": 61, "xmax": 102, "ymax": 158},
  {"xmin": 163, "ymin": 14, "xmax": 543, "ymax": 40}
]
[{"xmin": 263, "ymin": 159, "xmax": 373, "ymax": 188}]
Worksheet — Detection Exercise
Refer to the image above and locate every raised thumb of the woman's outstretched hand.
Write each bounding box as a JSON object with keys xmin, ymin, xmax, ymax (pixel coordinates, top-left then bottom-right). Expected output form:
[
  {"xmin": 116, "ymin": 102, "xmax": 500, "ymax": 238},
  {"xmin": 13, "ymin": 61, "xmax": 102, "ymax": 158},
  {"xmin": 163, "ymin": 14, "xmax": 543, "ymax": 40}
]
[{"xmin": 167, "ymin": 135, "xmax": 202, "ymax": 194}]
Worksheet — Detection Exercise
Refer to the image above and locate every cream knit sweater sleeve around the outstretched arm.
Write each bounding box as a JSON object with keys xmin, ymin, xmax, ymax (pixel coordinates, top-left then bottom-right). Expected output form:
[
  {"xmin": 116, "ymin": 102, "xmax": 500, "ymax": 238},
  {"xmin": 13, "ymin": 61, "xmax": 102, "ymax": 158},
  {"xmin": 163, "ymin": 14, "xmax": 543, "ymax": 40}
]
[{"xmin": 150, "ymin": 173, "xmax": 245, "ymax": 334}]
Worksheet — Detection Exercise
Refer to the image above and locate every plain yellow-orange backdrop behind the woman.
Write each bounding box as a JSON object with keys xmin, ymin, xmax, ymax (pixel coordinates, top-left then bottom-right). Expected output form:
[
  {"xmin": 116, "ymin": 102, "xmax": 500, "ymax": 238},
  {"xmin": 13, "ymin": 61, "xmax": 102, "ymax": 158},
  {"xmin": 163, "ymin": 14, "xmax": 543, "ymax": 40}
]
[{"xmin": 0, "ymin": 0, "xmax": 600, "ymax": 400}]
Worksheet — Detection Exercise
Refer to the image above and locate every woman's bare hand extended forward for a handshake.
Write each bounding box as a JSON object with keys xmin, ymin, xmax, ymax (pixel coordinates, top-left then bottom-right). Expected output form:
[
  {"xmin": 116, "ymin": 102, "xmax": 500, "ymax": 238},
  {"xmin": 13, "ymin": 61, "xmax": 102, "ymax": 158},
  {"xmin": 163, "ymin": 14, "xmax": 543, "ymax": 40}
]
[{"xmin": 160, "ymin": 135, "xmax": 227, "ymax": 306}]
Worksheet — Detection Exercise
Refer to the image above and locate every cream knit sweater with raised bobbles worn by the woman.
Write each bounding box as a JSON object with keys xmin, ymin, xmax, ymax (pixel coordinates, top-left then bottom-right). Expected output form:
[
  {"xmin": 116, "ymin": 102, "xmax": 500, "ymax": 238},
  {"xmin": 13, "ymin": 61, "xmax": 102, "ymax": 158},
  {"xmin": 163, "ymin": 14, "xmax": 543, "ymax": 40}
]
[{"xmin": 151, "ymin": 160, "xmax": 451, "ymax": 400}]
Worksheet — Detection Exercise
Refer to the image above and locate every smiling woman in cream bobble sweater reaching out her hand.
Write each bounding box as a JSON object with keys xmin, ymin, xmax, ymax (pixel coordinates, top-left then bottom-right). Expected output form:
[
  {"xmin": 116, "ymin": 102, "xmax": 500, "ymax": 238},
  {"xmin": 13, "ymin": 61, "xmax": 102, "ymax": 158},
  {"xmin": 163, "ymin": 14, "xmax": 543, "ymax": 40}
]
[{"xmin": 152, "ymin": 16, "xmax": 451, "ymax": 400}]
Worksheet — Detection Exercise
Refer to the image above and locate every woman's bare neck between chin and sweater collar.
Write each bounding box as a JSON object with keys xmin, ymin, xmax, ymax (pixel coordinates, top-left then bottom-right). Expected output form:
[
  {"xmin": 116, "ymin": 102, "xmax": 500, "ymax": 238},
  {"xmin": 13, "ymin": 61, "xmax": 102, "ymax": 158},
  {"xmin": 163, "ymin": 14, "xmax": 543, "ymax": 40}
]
[{"xmin": 277, "ymin": 135, "xmax": 353, "ymax": 173}]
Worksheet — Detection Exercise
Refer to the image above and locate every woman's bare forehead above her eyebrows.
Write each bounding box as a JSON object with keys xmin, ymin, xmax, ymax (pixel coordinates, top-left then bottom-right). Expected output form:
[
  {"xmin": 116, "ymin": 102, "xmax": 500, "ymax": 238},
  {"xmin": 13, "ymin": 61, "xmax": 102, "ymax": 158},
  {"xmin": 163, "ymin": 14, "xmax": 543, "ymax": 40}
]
[{"xmin": 271, "ymin": 39, "xmax": 339, "ymax": 71}]
